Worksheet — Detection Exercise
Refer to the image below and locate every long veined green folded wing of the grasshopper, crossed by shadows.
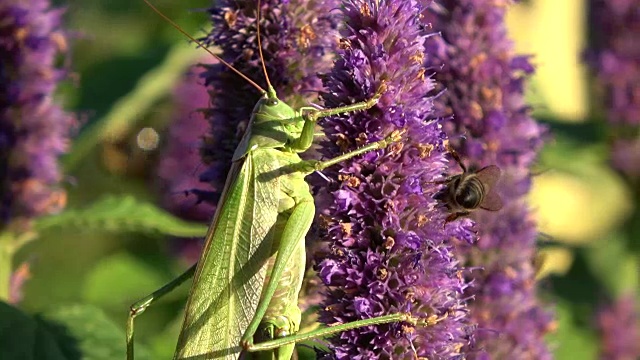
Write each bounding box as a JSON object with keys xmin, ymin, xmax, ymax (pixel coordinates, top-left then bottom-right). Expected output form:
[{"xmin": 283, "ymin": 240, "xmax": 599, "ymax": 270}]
[{"xmin": 174, "ymin": 152, "xmax": 280, "ymax": 359}]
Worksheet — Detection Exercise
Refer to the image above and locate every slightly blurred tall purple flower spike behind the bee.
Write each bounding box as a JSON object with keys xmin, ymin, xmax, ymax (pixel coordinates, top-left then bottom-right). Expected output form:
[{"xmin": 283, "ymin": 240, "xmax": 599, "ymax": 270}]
[{"xmin": 423, "ymin": 0, "xmax": 555, "ymax": 360}]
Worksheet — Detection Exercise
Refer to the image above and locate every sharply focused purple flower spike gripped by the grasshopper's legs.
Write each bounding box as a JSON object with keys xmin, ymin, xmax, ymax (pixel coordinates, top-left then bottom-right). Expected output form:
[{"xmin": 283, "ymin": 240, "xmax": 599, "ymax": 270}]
[{"xmin": 316, "ymin": 0, "xmax": 474, "ymax": 359}]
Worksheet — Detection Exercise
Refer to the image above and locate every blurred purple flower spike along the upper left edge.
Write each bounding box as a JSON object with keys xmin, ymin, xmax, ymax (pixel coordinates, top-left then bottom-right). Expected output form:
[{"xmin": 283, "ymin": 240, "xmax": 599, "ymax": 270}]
[{"xmin": 0, "ymin": 0, "xmax": 76, "ymax": 228}]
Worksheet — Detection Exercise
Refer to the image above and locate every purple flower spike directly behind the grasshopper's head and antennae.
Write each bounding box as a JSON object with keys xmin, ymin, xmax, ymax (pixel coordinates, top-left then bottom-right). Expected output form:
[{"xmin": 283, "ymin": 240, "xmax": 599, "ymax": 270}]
[{"xmin": 197, "ymin": 0, "xmax": 338, "ymax": 205}]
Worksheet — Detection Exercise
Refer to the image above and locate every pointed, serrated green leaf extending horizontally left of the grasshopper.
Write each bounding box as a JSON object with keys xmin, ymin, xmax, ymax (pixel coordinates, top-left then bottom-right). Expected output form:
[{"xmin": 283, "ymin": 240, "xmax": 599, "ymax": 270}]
[{"xmin": 36, "ymin": 196, "xmax": 207, "ymax": 237}]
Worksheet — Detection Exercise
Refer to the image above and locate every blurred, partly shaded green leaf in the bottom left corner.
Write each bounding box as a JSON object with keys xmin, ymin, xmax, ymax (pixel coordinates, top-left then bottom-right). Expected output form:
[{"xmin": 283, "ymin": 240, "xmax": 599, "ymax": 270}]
[{"xmin": 0, "ymin": 303, "xmax": 151, "ymax": 360}]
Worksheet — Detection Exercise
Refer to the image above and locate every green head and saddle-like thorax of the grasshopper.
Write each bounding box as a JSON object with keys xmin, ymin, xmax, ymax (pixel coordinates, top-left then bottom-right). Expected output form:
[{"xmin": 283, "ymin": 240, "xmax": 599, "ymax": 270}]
[{"xmin": 233, "ymin": 86, "xmax": 304, "ymax": 161}]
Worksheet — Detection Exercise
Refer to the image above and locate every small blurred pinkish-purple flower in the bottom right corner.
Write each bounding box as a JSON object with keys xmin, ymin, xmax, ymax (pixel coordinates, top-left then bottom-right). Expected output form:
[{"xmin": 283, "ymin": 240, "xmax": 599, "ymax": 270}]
[{"xmin": 598, "ymin": 295, "xmax": 640, "ymax": 360}]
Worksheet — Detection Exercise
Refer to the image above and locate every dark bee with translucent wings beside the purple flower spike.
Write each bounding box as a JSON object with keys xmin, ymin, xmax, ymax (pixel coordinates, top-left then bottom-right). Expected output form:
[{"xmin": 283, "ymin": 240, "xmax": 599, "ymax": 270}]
[{"xmin": 436, "ymin": 146, "xmax": 502, "ymax": 223}]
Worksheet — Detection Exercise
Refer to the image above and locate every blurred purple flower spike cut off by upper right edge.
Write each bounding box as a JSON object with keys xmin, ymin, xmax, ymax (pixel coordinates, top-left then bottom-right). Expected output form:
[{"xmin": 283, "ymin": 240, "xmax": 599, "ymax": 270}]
[{"xmin": 586, "ymin": 0, "xmax": 640, "ymax": 179}]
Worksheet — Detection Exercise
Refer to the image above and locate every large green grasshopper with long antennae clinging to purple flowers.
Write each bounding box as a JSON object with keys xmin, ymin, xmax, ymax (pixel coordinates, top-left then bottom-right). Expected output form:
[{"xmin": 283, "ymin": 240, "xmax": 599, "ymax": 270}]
[{"xmin": 127, "ymin": 0, "xmax": 416, "ymax": 360}]
